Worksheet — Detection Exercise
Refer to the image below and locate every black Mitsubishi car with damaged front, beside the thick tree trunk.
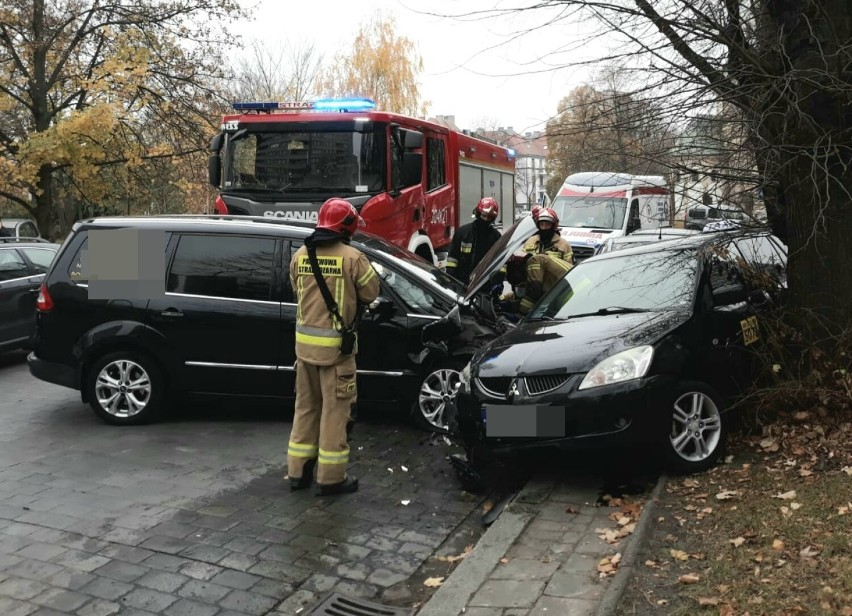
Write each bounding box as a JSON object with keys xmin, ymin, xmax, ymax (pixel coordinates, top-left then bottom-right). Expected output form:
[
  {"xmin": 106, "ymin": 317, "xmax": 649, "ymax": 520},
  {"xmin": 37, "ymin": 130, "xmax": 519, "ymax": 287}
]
[{"xmin": 436, "ymin": 232, "xmax": 786, "ymax": 473}]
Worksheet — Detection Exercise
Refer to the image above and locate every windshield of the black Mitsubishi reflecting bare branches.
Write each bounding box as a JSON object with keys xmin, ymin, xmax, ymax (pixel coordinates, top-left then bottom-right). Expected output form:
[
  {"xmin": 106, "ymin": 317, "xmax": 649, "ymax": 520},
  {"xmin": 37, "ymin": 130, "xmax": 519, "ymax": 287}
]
[{"xmin": 529, "ymin": 250, "xmax": 698, "ymax": 321}]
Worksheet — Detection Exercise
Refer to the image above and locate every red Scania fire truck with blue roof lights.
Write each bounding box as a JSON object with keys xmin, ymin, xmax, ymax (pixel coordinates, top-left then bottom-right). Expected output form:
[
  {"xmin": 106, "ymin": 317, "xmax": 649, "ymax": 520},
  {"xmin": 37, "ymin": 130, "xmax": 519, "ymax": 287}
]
[{"xmin": 208, "ymin": 98, "xmax": 515, "ymax": 263}]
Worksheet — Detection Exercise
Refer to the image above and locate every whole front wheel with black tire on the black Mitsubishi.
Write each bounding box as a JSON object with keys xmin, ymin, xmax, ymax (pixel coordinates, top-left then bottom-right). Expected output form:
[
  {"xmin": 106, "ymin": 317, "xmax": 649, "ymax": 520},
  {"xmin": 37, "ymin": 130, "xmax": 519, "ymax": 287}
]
[{"xmin": 662, "ymin": 381, "xmax": 728, "ymax": 475}]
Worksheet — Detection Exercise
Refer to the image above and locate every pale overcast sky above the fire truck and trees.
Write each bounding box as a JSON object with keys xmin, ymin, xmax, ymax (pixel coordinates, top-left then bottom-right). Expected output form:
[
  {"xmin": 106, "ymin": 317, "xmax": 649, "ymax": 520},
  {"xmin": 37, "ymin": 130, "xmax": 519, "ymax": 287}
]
[{"xmin": 235, "ymin": 0, "xmax": 602, "ymax": 132}]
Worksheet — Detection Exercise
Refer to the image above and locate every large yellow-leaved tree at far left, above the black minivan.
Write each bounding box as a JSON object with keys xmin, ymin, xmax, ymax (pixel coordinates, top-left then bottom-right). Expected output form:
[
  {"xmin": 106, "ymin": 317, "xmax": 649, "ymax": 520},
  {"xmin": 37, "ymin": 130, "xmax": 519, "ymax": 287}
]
[{"xmin": 0, "ymin": 0, "xmax": 242, "ymax": 237}]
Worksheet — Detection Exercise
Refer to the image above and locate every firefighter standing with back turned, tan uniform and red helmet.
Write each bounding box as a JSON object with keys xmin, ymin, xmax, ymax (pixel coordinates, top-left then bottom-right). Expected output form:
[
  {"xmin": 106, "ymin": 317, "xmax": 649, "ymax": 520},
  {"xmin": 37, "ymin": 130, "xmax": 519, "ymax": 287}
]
[{"xmin": 287, "ymin": 198, "xmax": 379, "ymax": 496}]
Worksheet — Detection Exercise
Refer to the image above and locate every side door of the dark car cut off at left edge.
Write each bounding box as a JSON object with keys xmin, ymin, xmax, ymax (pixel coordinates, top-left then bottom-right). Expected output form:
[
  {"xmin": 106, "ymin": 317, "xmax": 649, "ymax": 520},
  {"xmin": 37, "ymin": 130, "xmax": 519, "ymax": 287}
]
[{"xmin": 0, "ymin": 246, "xmax": 41, "ymax": 348}]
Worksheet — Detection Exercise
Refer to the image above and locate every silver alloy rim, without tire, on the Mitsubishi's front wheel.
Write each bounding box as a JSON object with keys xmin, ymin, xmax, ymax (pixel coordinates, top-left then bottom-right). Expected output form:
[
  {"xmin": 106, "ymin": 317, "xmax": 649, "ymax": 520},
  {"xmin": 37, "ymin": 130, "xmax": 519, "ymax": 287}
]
[{"xmin": 669, "ymin": 391, "xmax": 722, "ymax": 465}]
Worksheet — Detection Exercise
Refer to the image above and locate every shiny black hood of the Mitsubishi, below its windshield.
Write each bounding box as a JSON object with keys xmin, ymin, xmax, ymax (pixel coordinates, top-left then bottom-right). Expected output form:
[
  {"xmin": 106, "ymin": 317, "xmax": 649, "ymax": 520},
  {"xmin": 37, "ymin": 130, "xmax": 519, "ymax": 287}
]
[{"xmin": 474, "ymin": 311, "xmax": 690, "ymax": 377}]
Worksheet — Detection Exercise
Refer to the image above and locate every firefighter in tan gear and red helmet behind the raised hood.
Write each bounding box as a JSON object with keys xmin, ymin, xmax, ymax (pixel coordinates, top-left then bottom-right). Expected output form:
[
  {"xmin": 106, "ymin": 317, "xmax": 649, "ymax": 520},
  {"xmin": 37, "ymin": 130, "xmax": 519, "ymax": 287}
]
[{"xmin": 520, "ymin": 207, "xmax": 574, "ymax": 314}]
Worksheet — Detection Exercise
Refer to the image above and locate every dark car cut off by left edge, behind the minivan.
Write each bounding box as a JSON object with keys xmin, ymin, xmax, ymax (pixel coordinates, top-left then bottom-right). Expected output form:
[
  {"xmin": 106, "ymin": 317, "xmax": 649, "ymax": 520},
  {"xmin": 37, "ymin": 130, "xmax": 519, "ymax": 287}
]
[{"xmin": 0, "ymin": 241, "xmax": 59, "ymax": 352}]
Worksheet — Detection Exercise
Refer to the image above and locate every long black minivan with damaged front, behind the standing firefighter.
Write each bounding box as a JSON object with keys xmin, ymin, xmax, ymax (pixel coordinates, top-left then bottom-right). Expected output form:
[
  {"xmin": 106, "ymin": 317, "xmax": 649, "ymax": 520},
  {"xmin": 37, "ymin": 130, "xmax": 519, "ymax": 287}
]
[{"xmin": 28, "ymin": 216, "xmax": 510, "ymax": 429}]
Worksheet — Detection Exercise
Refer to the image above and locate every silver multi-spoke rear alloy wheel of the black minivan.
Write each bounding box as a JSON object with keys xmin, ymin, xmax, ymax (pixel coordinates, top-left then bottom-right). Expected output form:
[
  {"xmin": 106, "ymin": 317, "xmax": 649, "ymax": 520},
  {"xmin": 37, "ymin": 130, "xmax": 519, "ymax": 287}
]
[{"xmin": 95, "ymin": 359, "xmax": 151, "ymax": 417}]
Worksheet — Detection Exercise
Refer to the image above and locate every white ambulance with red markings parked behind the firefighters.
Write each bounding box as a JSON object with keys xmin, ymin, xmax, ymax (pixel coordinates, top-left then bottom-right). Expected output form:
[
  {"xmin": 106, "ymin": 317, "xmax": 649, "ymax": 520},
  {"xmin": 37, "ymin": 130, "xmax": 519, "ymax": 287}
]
[{"xmin": 550, "ymin": 172, "xmax": 671, "ymax": 262}]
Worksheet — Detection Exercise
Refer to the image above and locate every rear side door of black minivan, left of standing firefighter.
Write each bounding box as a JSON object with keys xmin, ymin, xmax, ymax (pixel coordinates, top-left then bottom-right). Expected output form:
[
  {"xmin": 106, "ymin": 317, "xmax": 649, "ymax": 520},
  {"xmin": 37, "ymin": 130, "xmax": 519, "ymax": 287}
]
[{"xmin": 148, "ymin": 233, "xmax": 282, "ymax": 396}]
